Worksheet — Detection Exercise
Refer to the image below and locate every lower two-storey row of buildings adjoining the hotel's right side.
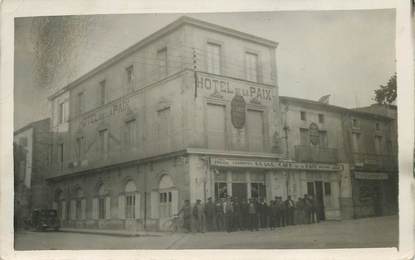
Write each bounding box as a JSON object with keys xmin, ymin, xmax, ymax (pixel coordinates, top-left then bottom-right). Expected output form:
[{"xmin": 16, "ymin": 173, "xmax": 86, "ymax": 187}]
[{"xmin": 280, "ymin": 97, "xmax": 398, "ymax": 219}]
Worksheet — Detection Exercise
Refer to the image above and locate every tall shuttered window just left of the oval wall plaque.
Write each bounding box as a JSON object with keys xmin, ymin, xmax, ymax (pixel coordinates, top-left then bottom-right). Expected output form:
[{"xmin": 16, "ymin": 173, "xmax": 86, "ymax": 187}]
[{"xmin": 207, "ymin": 104, "xmax": 226, "ymax": 150}]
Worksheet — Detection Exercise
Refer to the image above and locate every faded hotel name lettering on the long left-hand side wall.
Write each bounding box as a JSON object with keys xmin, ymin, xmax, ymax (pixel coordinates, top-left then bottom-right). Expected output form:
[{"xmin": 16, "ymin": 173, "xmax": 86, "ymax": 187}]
[{"xmin": 80, "ymin": 99, "xmax": 129, "ymax": 128}]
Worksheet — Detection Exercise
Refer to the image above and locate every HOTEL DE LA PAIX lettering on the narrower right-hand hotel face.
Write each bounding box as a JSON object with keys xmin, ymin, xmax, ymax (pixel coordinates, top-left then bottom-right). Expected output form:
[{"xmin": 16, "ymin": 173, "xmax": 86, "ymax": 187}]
[{"xmin": 197, "ymin": 75, "xmax": 272, "ymax": 101}]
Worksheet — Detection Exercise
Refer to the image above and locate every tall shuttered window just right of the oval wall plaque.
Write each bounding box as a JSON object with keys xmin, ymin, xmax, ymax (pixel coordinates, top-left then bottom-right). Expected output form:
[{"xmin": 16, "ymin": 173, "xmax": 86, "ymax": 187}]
[{"xmin": 247, "ymin": 110, "xmax": 264, "ymax": 152}]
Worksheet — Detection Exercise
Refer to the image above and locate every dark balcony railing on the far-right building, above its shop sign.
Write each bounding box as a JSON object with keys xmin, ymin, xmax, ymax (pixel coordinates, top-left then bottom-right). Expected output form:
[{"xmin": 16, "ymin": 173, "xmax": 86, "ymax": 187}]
[{"xmin": 353, "ymin": 153, "xmax": 398, "ymax": 170}]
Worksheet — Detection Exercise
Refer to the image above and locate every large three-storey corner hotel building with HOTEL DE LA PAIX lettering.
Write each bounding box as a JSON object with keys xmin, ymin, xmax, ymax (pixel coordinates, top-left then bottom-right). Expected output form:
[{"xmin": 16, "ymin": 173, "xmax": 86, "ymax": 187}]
[{"xmin": 48, "ymin": 17, "xmax": 338, "ymax": 230}]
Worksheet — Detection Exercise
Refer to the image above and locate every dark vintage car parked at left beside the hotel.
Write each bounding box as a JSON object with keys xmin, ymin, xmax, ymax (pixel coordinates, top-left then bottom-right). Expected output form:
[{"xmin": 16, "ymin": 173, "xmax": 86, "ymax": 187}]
[{"xmin": 31, "ymin": 209, "xmax": 60, "ymax": 231}]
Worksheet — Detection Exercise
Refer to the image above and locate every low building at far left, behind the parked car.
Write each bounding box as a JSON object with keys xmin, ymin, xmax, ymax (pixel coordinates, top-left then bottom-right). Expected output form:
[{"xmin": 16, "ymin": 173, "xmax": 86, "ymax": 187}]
[{"xmin": 14, "ymin": 119, "xmax": 51, "ymax": 228}]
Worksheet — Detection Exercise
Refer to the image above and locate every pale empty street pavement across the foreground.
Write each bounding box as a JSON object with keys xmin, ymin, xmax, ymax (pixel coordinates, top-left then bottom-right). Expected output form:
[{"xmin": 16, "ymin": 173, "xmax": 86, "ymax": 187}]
[{"xmin": 15, "ymin": 216, "xmax": 398, "ymax": 250}]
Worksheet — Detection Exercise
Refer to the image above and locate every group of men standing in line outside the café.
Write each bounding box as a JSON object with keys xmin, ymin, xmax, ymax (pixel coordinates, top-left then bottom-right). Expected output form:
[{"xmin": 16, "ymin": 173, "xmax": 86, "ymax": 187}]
[{"xmin": 178, "ymin": 194, "xmax": 321, "ymax": 232}]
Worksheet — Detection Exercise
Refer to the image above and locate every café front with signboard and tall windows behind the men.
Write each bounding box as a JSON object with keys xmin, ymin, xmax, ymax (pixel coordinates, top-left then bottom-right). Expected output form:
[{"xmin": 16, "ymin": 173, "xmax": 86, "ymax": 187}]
[{"xmin": 210, "ymin": 157, "xmax": 341, "ymax": 220}]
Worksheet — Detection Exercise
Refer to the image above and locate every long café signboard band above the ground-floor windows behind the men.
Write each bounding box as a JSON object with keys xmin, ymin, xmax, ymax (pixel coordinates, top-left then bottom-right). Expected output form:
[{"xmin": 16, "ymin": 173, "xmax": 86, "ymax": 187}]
[{"xmin": 210, "ymin": 157, "xmax": 343, "ymax": 172}]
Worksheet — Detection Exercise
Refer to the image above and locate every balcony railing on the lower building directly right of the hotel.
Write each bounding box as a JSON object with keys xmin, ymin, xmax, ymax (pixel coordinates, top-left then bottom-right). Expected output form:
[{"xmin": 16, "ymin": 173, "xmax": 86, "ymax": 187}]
[{"xmin": 295, "ymin": 145, "xmax": 338, "ymax": 163}]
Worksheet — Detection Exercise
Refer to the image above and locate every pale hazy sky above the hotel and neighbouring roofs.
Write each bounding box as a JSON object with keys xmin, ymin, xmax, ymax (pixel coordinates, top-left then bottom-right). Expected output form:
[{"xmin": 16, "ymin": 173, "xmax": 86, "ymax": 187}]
[{"xmin": 14, "ymin": 10, "xmax": 396, "ymax": 129}]
